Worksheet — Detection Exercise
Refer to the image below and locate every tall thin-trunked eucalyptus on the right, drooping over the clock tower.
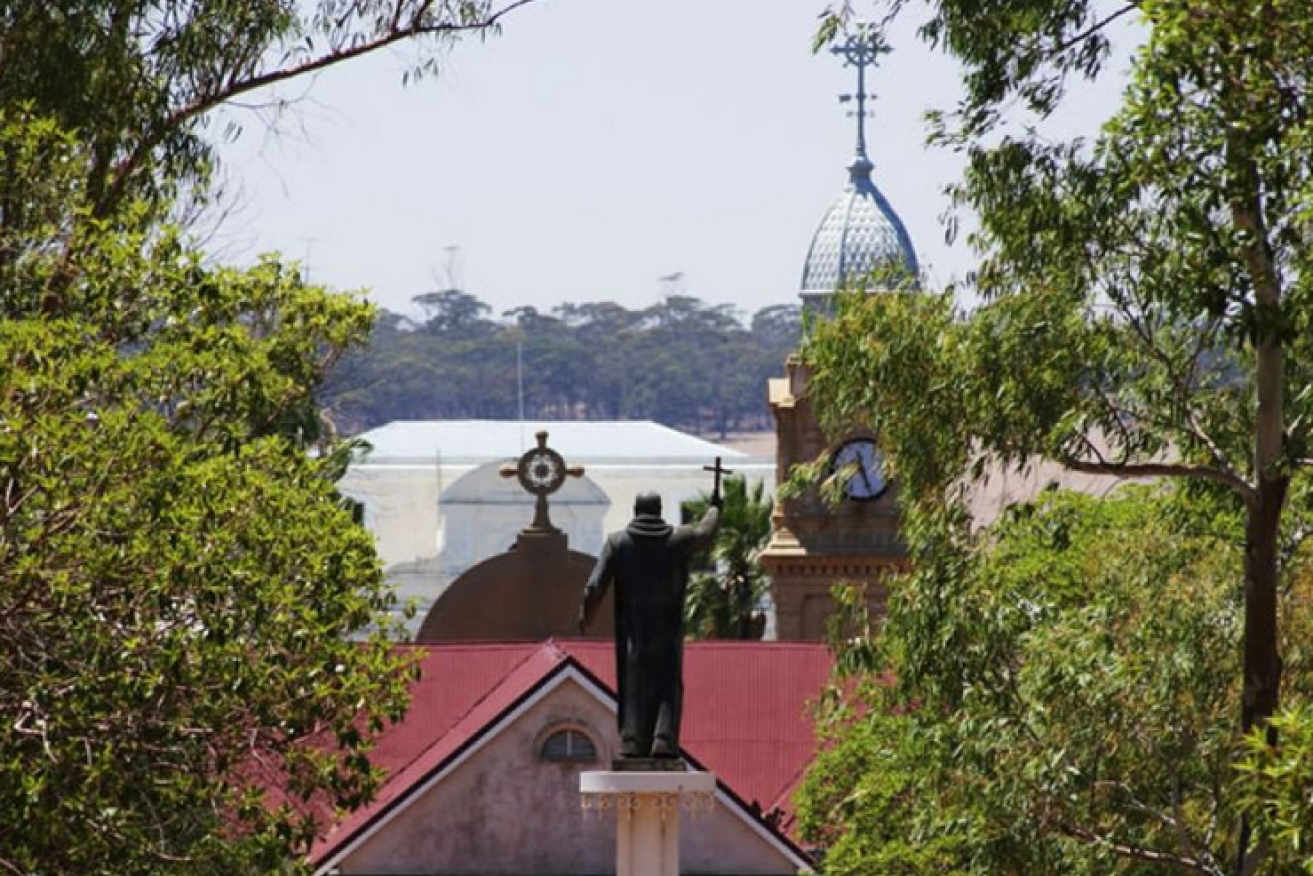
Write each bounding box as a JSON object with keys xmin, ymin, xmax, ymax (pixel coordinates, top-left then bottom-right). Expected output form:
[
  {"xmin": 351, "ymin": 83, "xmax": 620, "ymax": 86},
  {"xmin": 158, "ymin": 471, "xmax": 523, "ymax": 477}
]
[{"xmin": 809, "ymin": 0, "xmax": 1313, "ymax": 873}]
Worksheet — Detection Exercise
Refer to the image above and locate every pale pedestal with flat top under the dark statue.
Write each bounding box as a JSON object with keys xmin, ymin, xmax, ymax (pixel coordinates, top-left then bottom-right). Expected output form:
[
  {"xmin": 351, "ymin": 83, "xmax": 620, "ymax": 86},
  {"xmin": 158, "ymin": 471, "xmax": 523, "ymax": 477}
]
[{"xmin": 579, "ymin": 771, "xmax": 716, "ymax": 876}]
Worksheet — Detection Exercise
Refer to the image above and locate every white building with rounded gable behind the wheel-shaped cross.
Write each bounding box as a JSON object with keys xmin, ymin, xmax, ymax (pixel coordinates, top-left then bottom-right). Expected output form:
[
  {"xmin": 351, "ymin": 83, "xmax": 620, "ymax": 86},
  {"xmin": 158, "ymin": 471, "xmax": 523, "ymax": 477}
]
[{"xmin": 339, "ymin": 420, "xmax": 775, "ymax": 634}]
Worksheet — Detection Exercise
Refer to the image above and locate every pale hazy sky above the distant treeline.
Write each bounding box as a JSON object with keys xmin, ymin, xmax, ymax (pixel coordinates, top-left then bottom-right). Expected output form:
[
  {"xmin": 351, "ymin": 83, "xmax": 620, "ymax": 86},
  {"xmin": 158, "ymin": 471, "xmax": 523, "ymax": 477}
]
[{"xmin": 214, "ymin": 0, "xmax": 1116, "ymax": 320}]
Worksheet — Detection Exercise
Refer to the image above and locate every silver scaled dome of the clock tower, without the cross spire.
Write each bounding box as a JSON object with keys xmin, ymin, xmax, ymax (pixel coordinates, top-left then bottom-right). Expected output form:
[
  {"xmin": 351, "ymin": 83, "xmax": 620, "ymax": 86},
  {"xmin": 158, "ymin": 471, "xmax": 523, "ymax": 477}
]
[{"xmin": 801, "ymin": 152, "xmax": 916, "ymax": 298}]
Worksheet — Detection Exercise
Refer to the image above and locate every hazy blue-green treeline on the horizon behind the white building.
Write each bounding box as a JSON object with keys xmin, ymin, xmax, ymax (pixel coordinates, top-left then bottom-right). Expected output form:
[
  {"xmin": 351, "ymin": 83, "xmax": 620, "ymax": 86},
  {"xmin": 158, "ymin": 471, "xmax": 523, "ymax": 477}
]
[{"xmin": 324, "ymin": 290, "xmax": 801, "ymax": 436}]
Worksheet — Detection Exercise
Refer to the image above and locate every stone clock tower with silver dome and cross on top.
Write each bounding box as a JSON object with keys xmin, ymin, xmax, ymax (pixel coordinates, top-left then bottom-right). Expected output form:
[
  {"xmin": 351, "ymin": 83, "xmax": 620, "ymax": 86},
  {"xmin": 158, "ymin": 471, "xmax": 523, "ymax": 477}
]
[{"xmin": 760, "ymin": 29, "xmax": 918, "ymax": 641}]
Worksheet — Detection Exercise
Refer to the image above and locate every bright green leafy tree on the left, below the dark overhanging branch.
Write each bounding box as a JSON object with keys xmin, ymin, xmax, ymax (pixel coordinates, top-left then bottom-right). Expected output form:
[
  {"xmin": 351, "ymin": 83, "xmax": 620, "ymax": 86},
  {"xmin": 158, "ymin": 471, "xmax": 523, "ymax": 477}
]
[{"xmin": 0, "ymin": 112, "xmax": 410, "ymax": 873}]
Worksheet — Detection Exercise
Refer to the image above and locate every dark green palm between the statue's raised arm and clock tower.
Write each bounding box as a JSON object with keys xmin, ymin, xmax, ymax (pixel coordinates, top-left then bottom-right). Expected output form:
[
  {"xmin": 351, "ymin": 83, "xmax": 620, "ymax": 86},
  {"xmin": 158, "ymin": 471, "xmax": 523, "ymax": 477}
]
[{"xmin": 683, "ymin": 475, "xmax": 773, "ymax": 640}]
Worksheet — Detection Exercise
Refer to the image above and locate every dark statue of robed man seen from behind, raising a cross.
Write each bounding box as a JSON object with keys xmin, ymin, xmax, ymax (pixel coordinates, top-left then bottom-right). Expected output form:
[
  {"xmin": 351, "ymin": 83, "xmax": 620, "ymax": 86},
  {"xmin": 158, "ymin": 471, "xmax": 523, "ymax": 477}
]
[{"xmin": 580, "ymin": 483, "xmax": 721, "ymax": 759}]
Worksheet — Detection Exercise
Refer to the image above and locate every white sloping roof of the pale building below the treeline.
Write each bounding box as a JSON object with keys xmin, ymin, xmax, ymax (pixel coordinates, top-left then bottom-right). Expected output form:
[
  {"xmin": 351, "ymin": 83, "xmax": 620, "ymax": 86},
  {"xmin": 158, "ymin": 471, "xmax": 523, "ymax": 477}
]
[{"xmin": 360, "ymin": 420, "xmax": 747, "ymax": 465}]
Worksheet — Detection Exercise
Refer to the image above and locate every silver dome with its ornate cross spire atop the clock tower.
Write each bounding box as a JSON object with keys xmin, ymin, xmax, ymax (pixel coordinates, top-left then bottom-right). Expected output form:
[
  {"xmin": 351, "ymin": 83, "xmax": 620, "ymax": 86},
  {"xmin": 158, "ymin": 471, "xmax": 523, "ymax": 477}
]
[{"xmin": 800, "ymin": 33, "xmax": 918, "ymax": 303}]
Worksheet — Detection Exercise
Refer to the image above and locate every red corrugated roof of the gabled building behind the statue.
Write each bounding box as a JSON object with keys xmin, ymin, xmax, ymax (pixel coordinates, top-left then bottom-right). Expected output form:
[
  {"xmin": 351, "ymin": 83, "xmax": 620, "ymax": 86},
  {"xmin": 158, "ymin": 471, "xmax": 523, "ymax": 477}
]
[{"xmin": 311, "ymin": 640, "xmax": 831, "ymax": 863}]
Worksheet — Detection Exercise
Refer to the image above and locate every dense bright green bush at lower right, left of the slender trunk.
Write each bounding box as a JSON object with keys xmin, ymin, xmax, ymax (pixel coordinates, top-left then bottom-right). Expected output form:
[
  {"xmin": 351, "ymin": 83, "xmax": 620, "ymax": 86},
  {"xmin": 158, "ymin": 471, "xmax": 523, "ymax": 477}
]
[{"xmin": 801, "ymin": 487, "xmax": 1313, "ymax": 873}]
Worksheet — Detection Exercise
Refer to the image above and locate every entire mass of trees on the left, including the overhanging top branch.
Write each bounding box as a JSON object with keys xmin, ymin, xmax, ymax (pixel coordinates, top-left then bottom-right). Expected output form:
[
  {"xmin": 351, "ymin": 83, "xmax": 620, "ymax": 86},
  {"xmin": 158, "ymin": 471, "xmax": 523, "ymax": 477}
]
[{"xmin": 0, "ymin": 0, "xmax": 538, "ymax": 875}]
